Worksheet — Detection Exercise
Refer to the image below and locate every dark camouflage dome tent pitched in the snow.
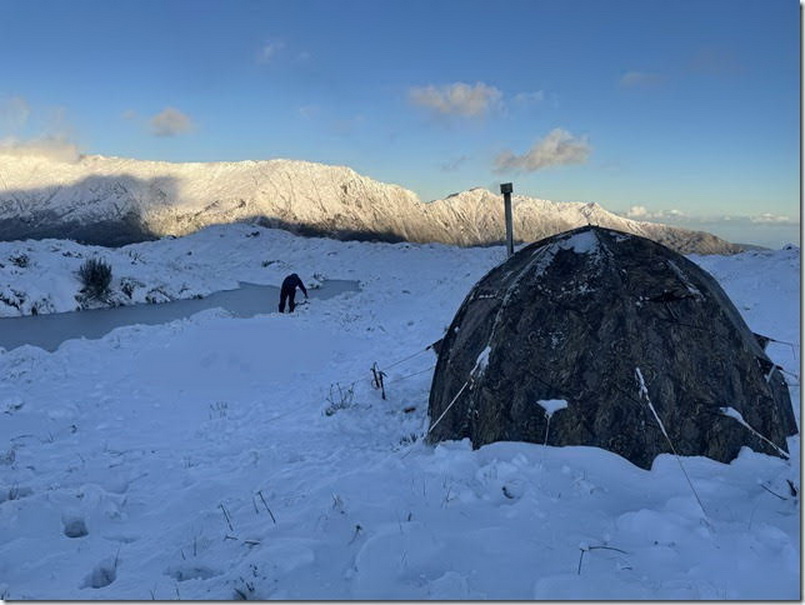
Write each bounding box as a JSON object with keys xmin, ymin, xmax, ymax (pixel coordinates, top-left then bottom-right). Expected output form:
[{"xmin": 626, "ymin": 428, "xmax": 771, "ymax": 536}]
[{"xmin": 428, "ymin": 226, "xmax": 797, "ymax": 469}]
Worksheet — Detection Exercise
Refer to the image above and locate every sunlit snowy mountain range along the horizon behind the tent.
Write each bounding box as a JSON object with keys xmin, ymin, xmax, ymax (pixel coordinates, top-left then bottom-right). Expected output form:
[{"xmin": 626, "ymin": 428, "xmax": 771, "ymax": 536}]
[{"xmin": 0, "ymin": 154, "xmax": 743, "ymax": 254}]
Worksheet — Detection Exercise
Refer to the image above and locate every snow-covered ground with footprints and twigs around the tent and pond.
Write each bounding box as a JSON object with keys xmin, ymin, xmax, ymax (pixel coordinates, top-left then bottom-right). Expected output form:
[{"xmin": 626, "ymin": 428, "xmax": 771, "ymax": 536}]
[{"xmin": 0, "ymin": 225, "xmax": 802, "ymax": 600}]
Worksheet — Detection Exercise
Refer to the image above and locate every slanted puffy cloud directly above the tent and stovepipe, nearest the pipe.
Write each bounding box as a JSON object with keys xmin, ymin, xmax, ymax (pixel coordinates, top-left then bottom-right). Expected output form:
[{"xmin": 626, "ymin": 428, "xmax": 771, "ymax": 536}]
[{"xmin": 495, "ymin": 128, "xmax": 592, "ymax": 172}]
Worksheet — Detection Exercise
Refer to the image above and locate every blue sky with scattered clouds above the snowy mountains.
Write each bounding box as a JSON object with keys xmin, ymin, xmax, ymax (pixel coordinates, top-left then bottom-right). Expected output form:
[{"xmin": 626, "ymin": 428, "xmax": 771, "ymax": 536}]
[{"xmin": 0, "ymin": 0, "xmax": 800, "ymax": 247}]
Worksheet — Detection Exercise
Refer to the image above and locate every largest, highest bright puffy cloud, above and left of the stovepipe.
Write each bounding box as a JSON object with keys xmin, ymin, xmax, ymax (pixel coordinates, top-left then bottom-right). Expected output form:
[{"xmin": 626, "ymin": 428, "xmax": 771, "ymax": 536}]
[{"xmin": 408, "ymin": 82, "xmax": 503, "ymax": 117}]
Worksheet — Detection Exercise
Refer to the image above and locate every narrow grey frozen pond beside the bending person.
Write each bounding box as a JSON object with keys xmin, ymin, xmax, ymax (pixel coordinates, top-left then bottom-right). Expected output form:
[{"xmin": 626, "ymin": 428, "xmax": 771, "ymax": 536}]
[{"xmin": 0, "ymin": 279, "xmax": 360, "ymax": 351}]
